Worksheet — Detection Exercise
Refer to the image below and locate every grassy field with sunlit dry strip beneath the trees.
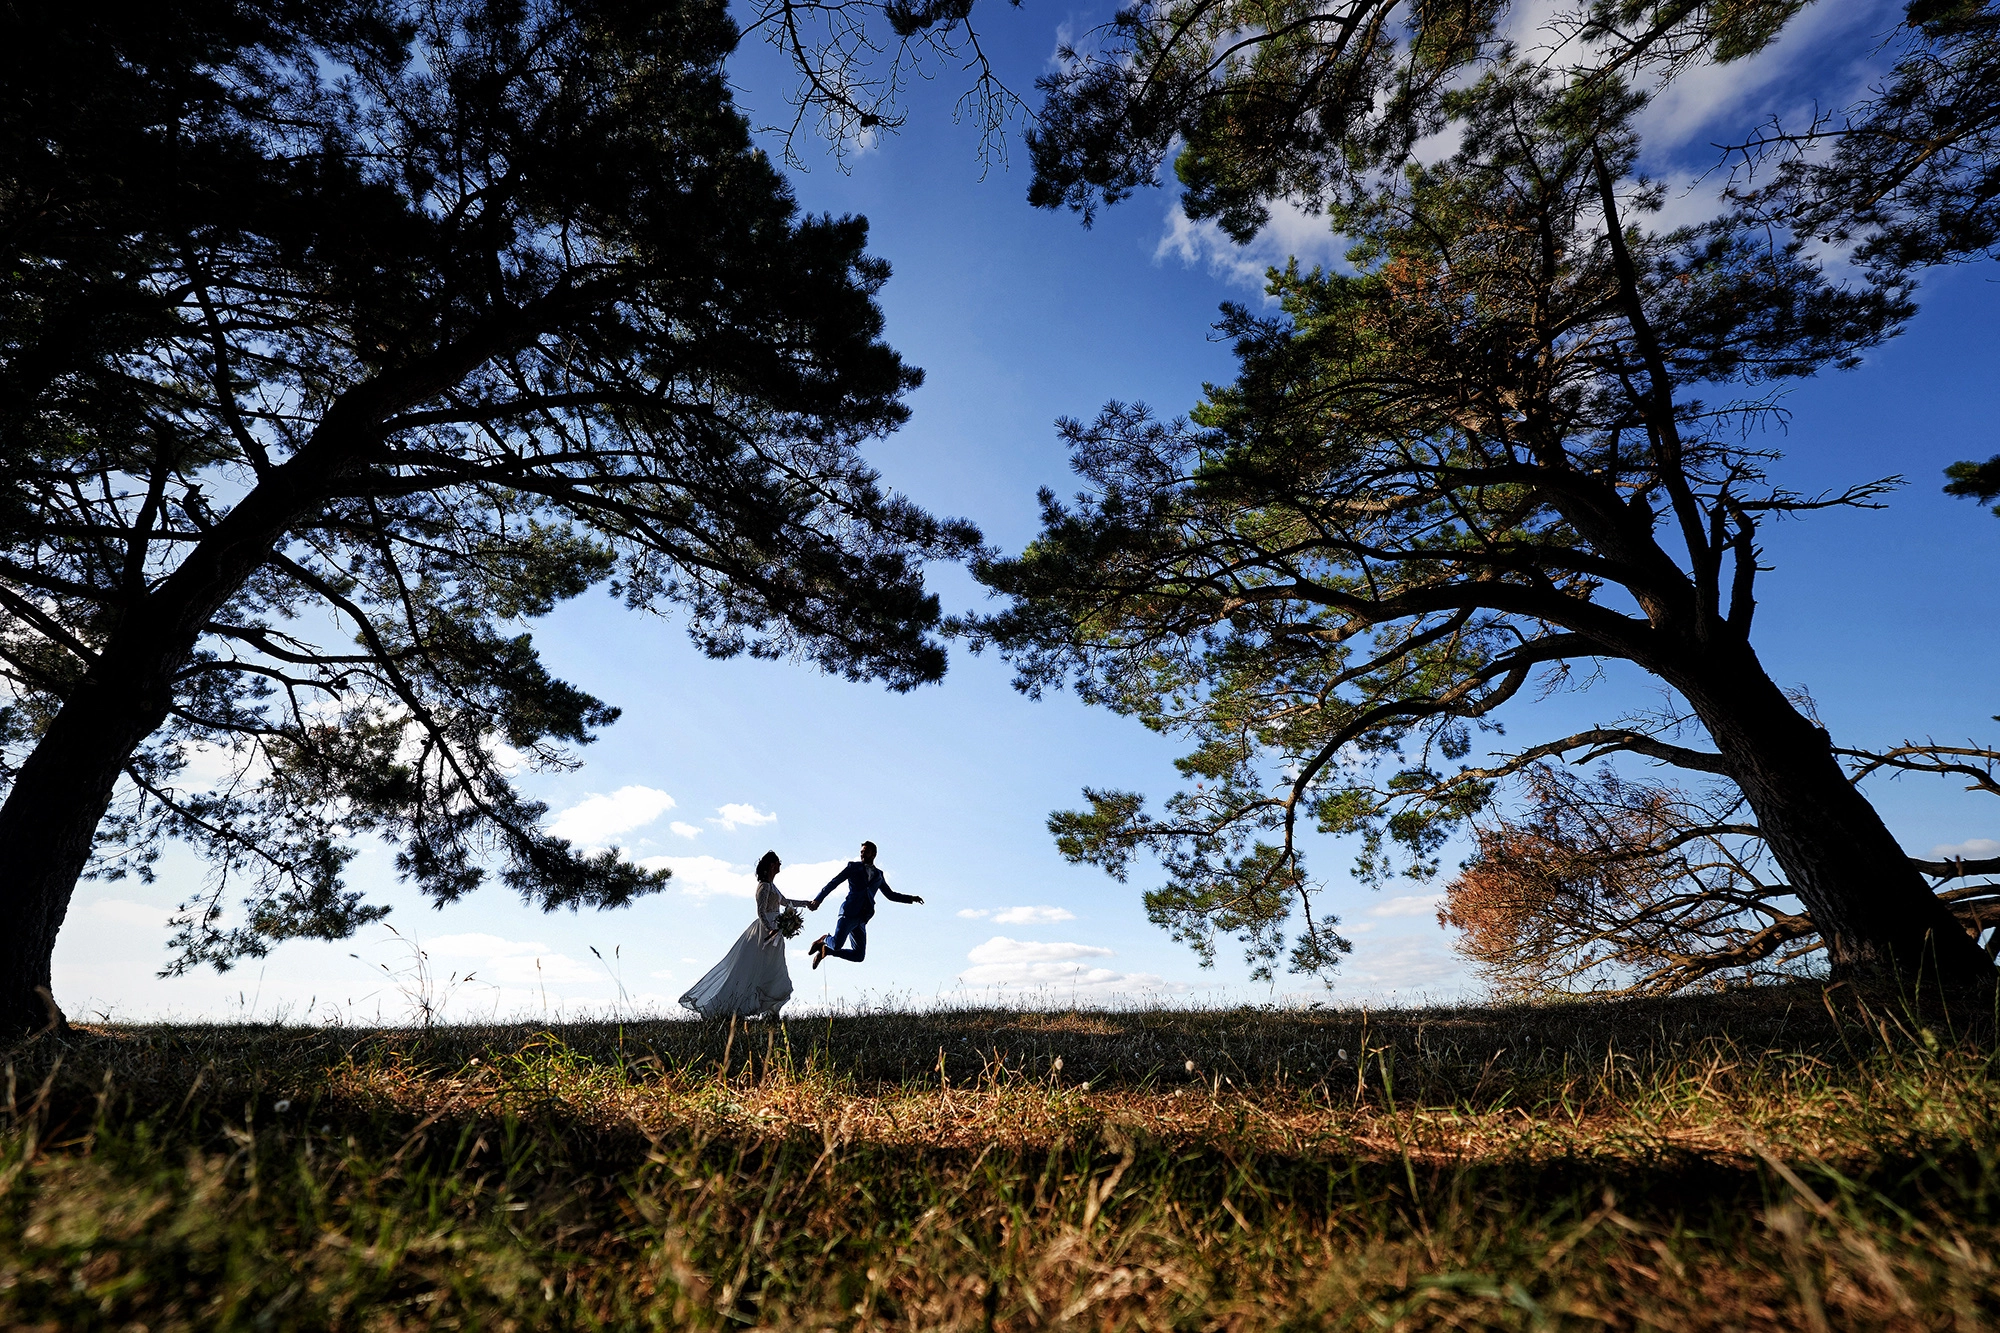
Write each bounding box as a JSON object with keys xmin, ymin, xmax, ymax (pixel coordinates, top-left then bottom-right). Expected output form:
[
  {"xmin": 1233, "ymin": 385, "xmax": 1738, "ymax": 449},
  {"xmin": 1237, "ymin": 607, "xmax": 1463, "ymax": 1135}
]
[{"xmin": 0, "ymin": 987, "xmax": 2000, "ymax": 1331}]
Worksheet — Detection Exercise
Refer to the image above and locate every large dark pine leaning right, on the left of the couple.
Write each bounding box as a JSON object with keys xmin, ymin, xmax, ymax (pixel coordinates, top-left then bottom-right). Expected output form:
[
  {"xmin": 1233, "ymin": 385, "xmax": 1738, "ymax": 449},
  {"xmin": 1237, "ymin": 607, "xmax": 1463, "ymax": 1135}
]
[{"xmin": 0, "ymin": 0, "xmax": 978, "ymax": 1025}]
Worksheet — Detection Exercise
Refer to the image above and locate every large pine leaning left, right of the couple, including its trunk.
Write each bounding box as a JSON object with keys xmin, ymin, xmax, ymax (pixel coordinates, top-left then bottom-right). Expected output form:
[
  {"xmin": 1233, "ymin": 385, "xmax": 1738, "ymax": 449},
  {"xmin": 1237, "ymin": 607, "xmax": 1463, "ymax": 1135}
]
[{"xmin": 978, "ymin": 64, "xmax": 1986, "ymax": 979}]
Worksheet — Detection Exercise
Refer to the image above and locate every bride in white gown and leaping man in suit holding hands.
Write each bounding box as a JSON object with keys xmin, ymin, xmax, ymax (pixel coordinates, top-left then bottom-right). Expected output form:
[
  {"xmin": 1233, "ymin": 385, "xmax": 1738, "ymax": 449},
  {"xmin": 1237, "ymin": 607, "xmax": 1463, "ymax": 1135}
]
[{"xmin": 680, "ymin": 843, "xmax": 924, "ymax": 1019}]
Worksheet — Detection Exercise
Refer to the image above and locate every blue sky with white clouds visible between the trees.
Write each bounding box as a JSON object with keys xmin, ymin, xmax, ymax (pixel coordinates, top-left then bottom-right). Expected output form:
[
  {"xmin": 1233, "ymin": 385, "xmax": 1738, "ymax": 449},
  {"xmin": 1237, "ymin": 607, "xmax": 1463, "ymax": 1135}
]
[{"xmin": 56, "ymin": 2, "xmax": 2000, "ymax": 1021}]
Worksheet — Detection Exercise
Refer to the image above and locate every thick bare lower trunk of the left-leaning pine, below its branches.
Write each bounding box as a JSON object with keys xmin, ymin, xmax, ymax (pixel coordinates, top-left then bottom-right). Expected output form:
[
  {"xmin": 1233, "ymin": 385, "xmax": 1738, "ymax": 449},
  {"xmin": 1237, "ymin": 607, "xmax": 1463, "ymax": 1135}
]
[{"xmin": 1660, "ymin": 640, "xmax": 1994, "ymax": 987}]
